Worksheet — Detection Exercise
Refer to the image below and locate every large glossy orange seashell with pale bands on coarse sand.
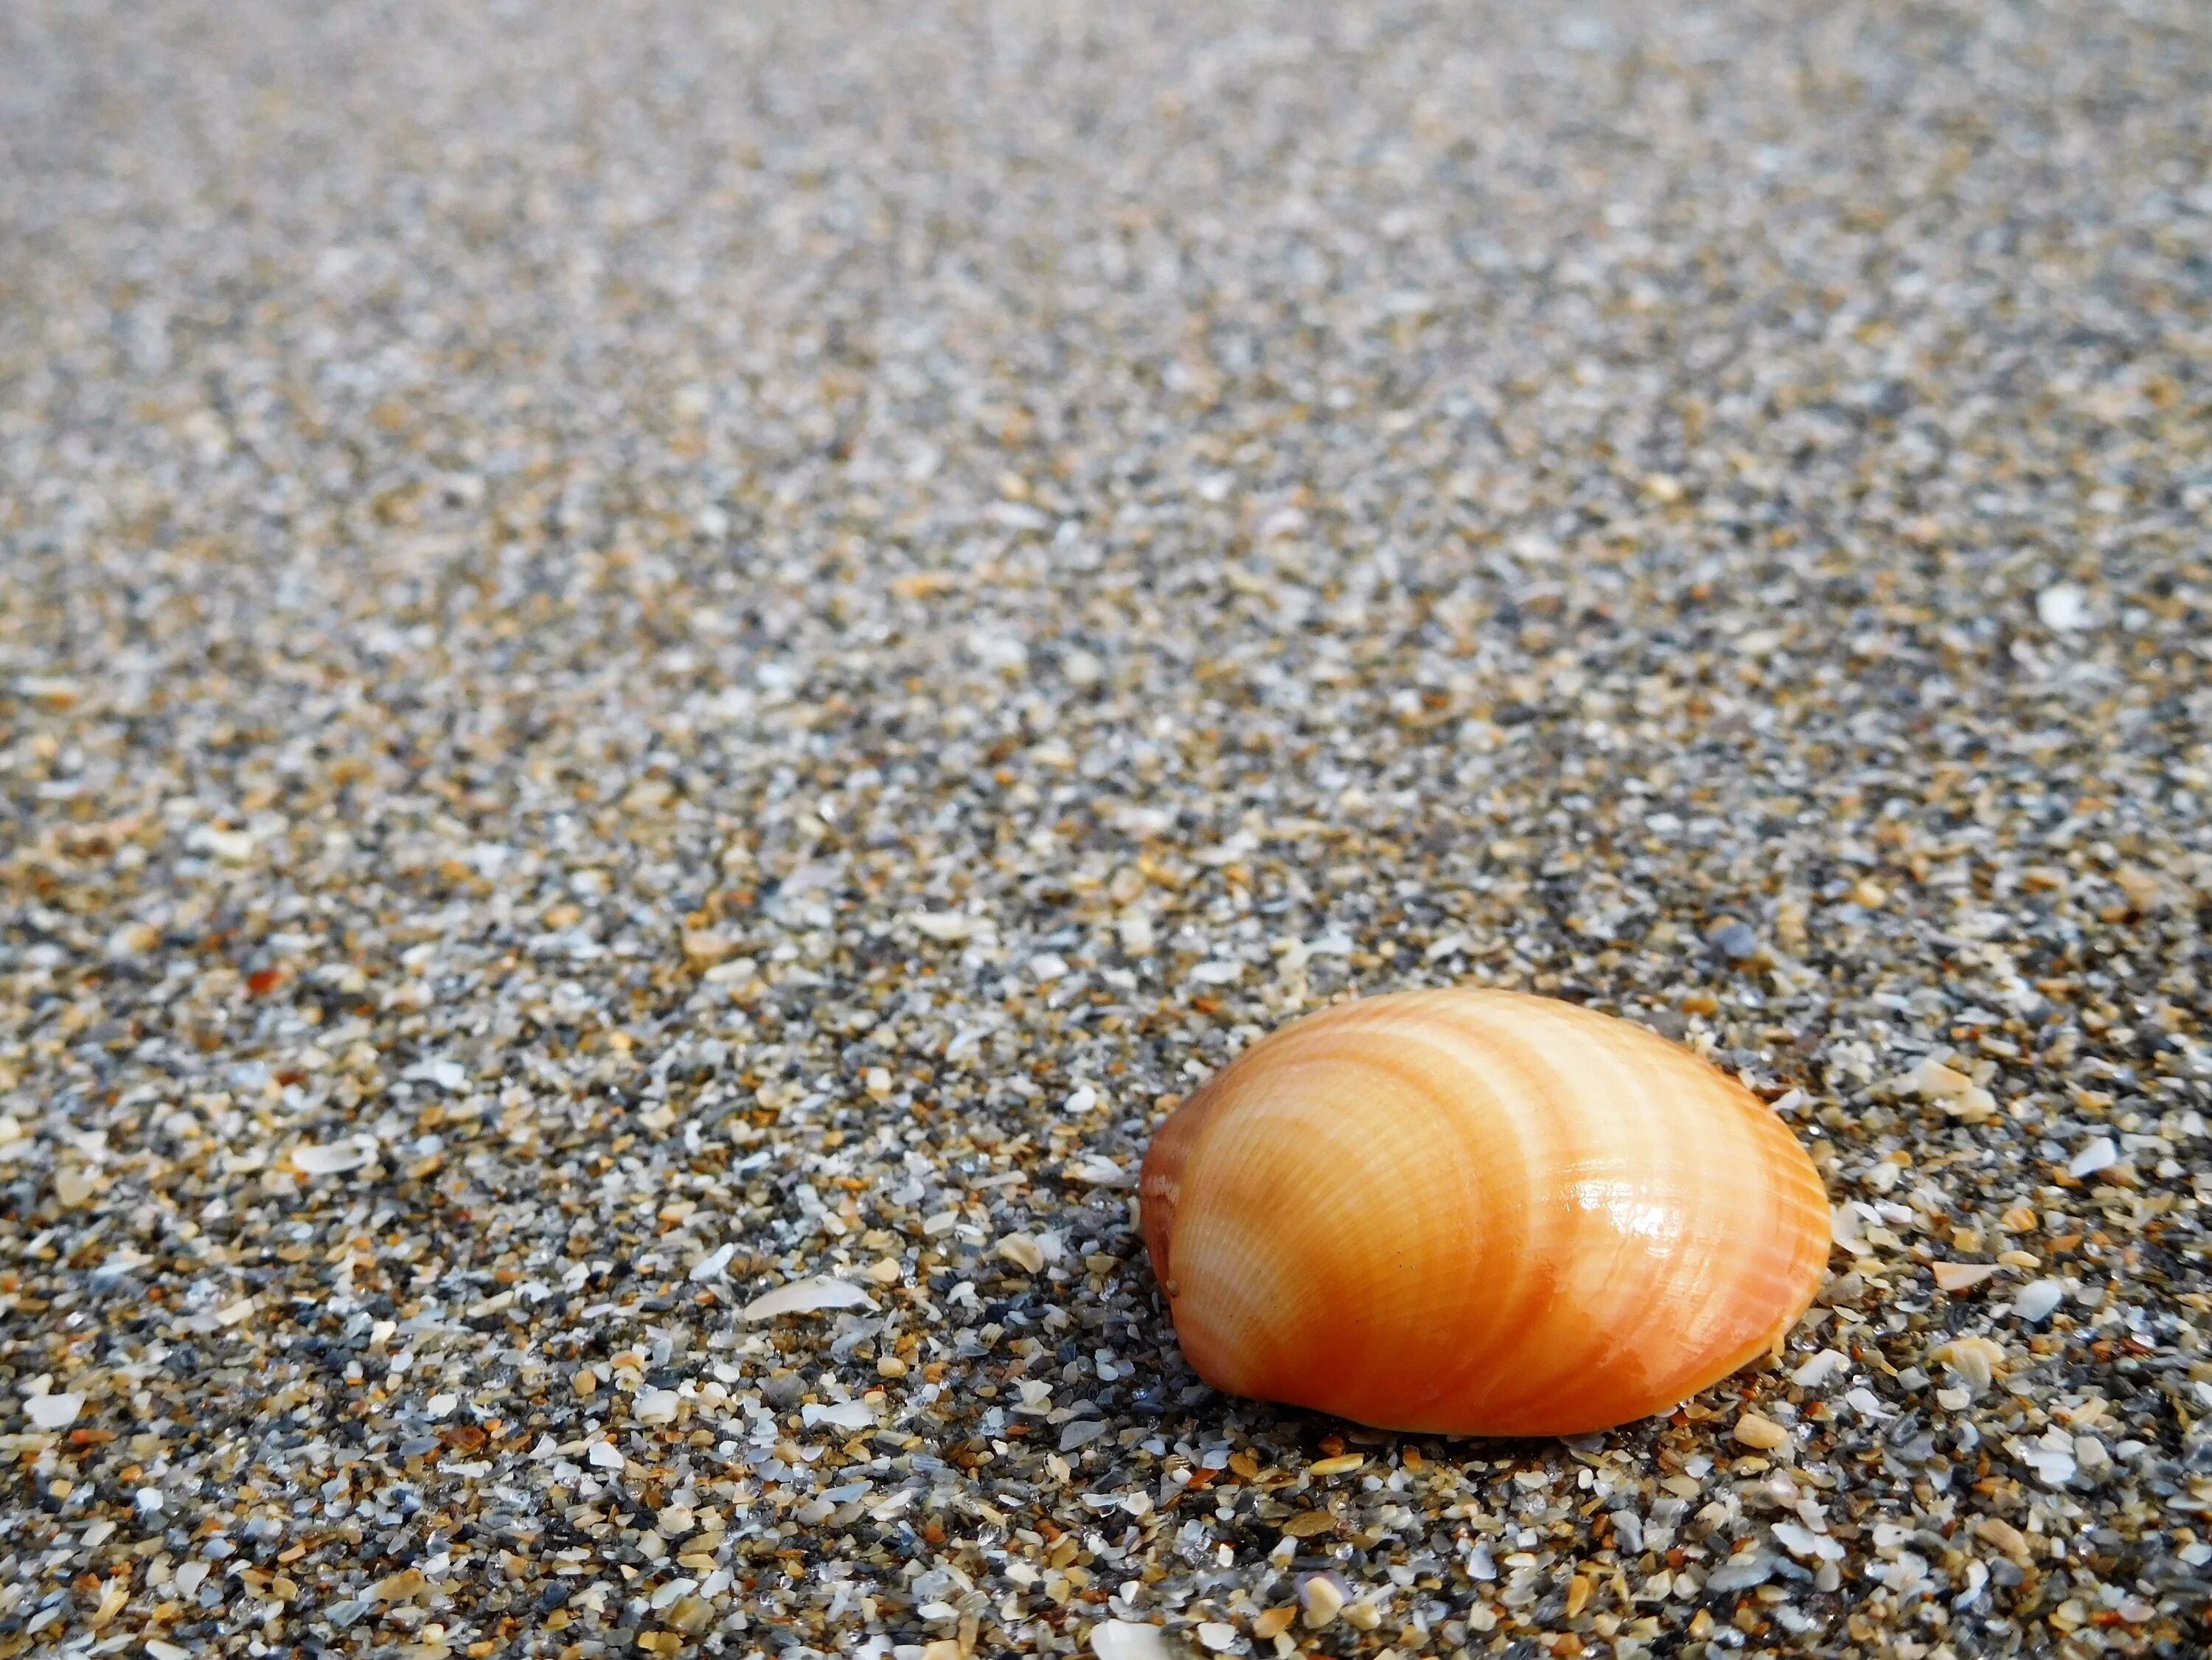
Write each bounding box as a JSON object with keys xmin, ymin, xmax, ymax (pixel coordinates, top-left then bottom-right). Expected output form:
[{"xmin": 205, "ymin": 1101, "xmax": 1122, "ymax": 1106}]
[{"xmin": 1141, "ymin": 990, "xmax": 1829, "ymax": 1437}]
